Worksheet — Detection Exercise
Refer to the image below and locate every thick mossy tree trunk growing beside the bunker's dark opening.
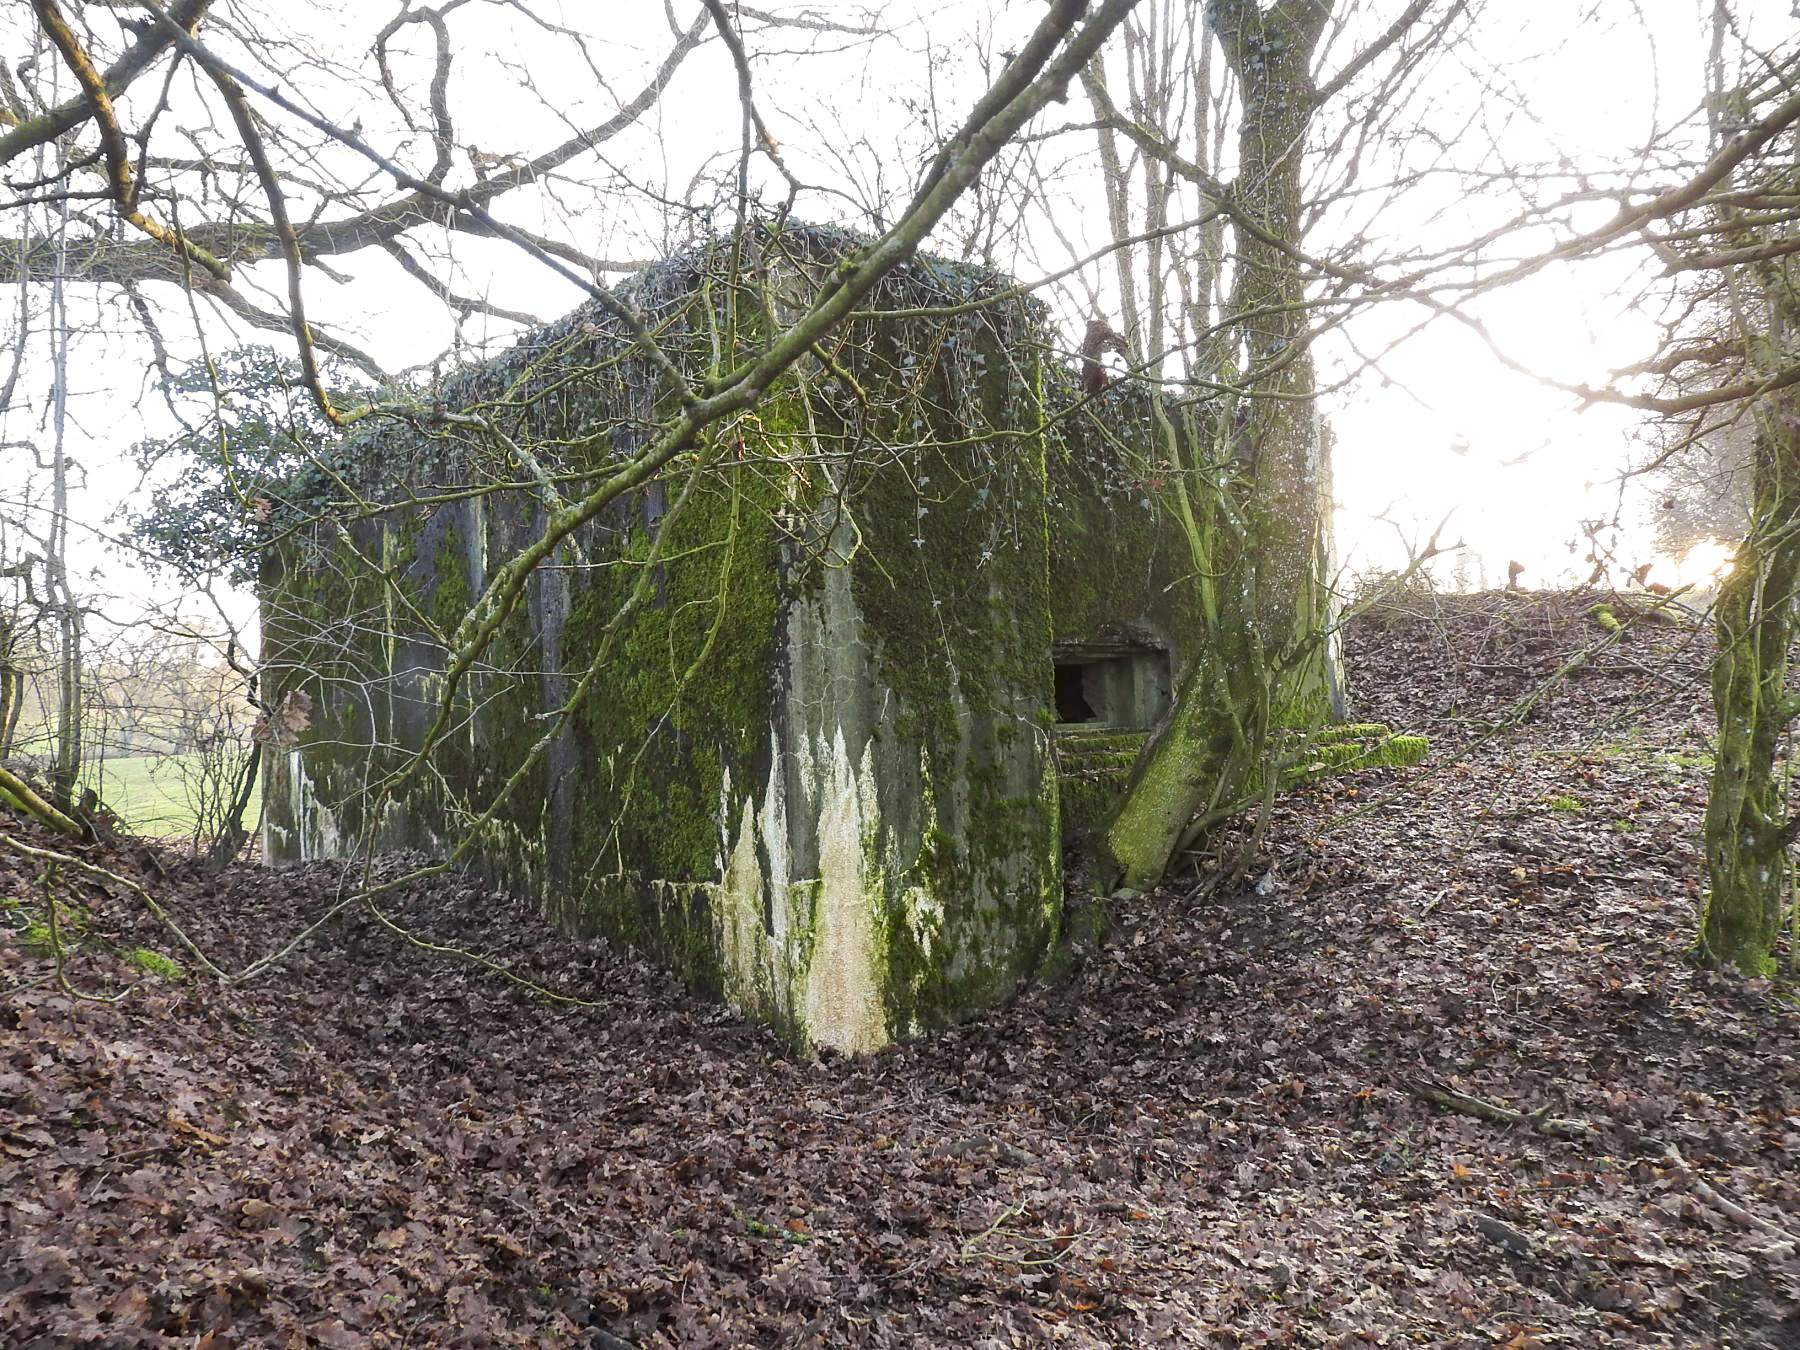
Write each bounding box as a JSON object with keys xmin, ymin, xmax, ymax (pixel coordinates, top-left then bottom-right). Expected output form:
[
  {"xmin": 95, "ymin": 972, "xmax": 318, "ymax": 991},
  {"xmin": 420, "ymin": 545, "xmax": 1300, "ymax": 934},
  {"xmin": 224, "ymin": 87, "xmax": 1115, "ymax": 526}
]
[{"xmin": 1107, "ymin": 0, "xmax": 1330, "ymax": 887}]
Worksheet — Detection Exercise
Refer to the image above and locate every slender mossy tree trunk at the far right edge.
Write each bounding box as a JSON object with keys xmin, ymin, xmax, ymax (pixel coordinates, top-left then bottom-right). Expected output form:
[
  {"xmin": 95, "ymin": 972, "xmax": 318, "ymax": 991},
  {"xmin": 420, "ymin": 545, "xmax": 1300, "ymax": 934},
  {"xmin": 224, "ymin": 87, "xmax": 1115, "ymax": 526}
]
[{"xmin": 1699, "ymin": 293, "xmax": 1800, "ymax": 976}]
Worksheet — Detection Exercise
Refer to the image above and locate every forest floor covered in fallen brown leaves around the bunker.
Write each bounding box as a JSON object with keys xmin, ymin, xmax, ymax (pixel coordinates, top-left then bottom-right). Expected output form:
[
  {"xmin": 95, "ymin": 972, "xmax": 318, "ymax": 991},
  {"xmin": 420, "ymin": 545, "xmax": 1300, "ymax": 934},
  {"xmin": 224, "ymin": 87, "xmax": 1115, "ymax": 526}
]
[{"xmin": 0, "ymin": 596, "xmax": 1800, "ymax": 1350}]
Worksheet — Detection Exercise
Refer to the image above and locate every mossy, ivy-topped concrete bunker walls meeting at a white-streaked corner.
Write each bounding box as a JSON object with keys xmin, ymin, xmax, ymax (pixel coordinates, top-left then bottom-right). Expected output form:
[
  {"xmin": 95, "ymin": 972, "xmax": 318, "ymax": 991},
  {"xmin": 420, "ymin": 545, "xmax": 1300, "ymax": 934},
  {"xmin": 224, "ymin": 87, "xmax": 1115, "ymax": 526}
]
[{"xmin": 263, "ymin": 229, "xmax": 1181, "ymax": 1051}]
